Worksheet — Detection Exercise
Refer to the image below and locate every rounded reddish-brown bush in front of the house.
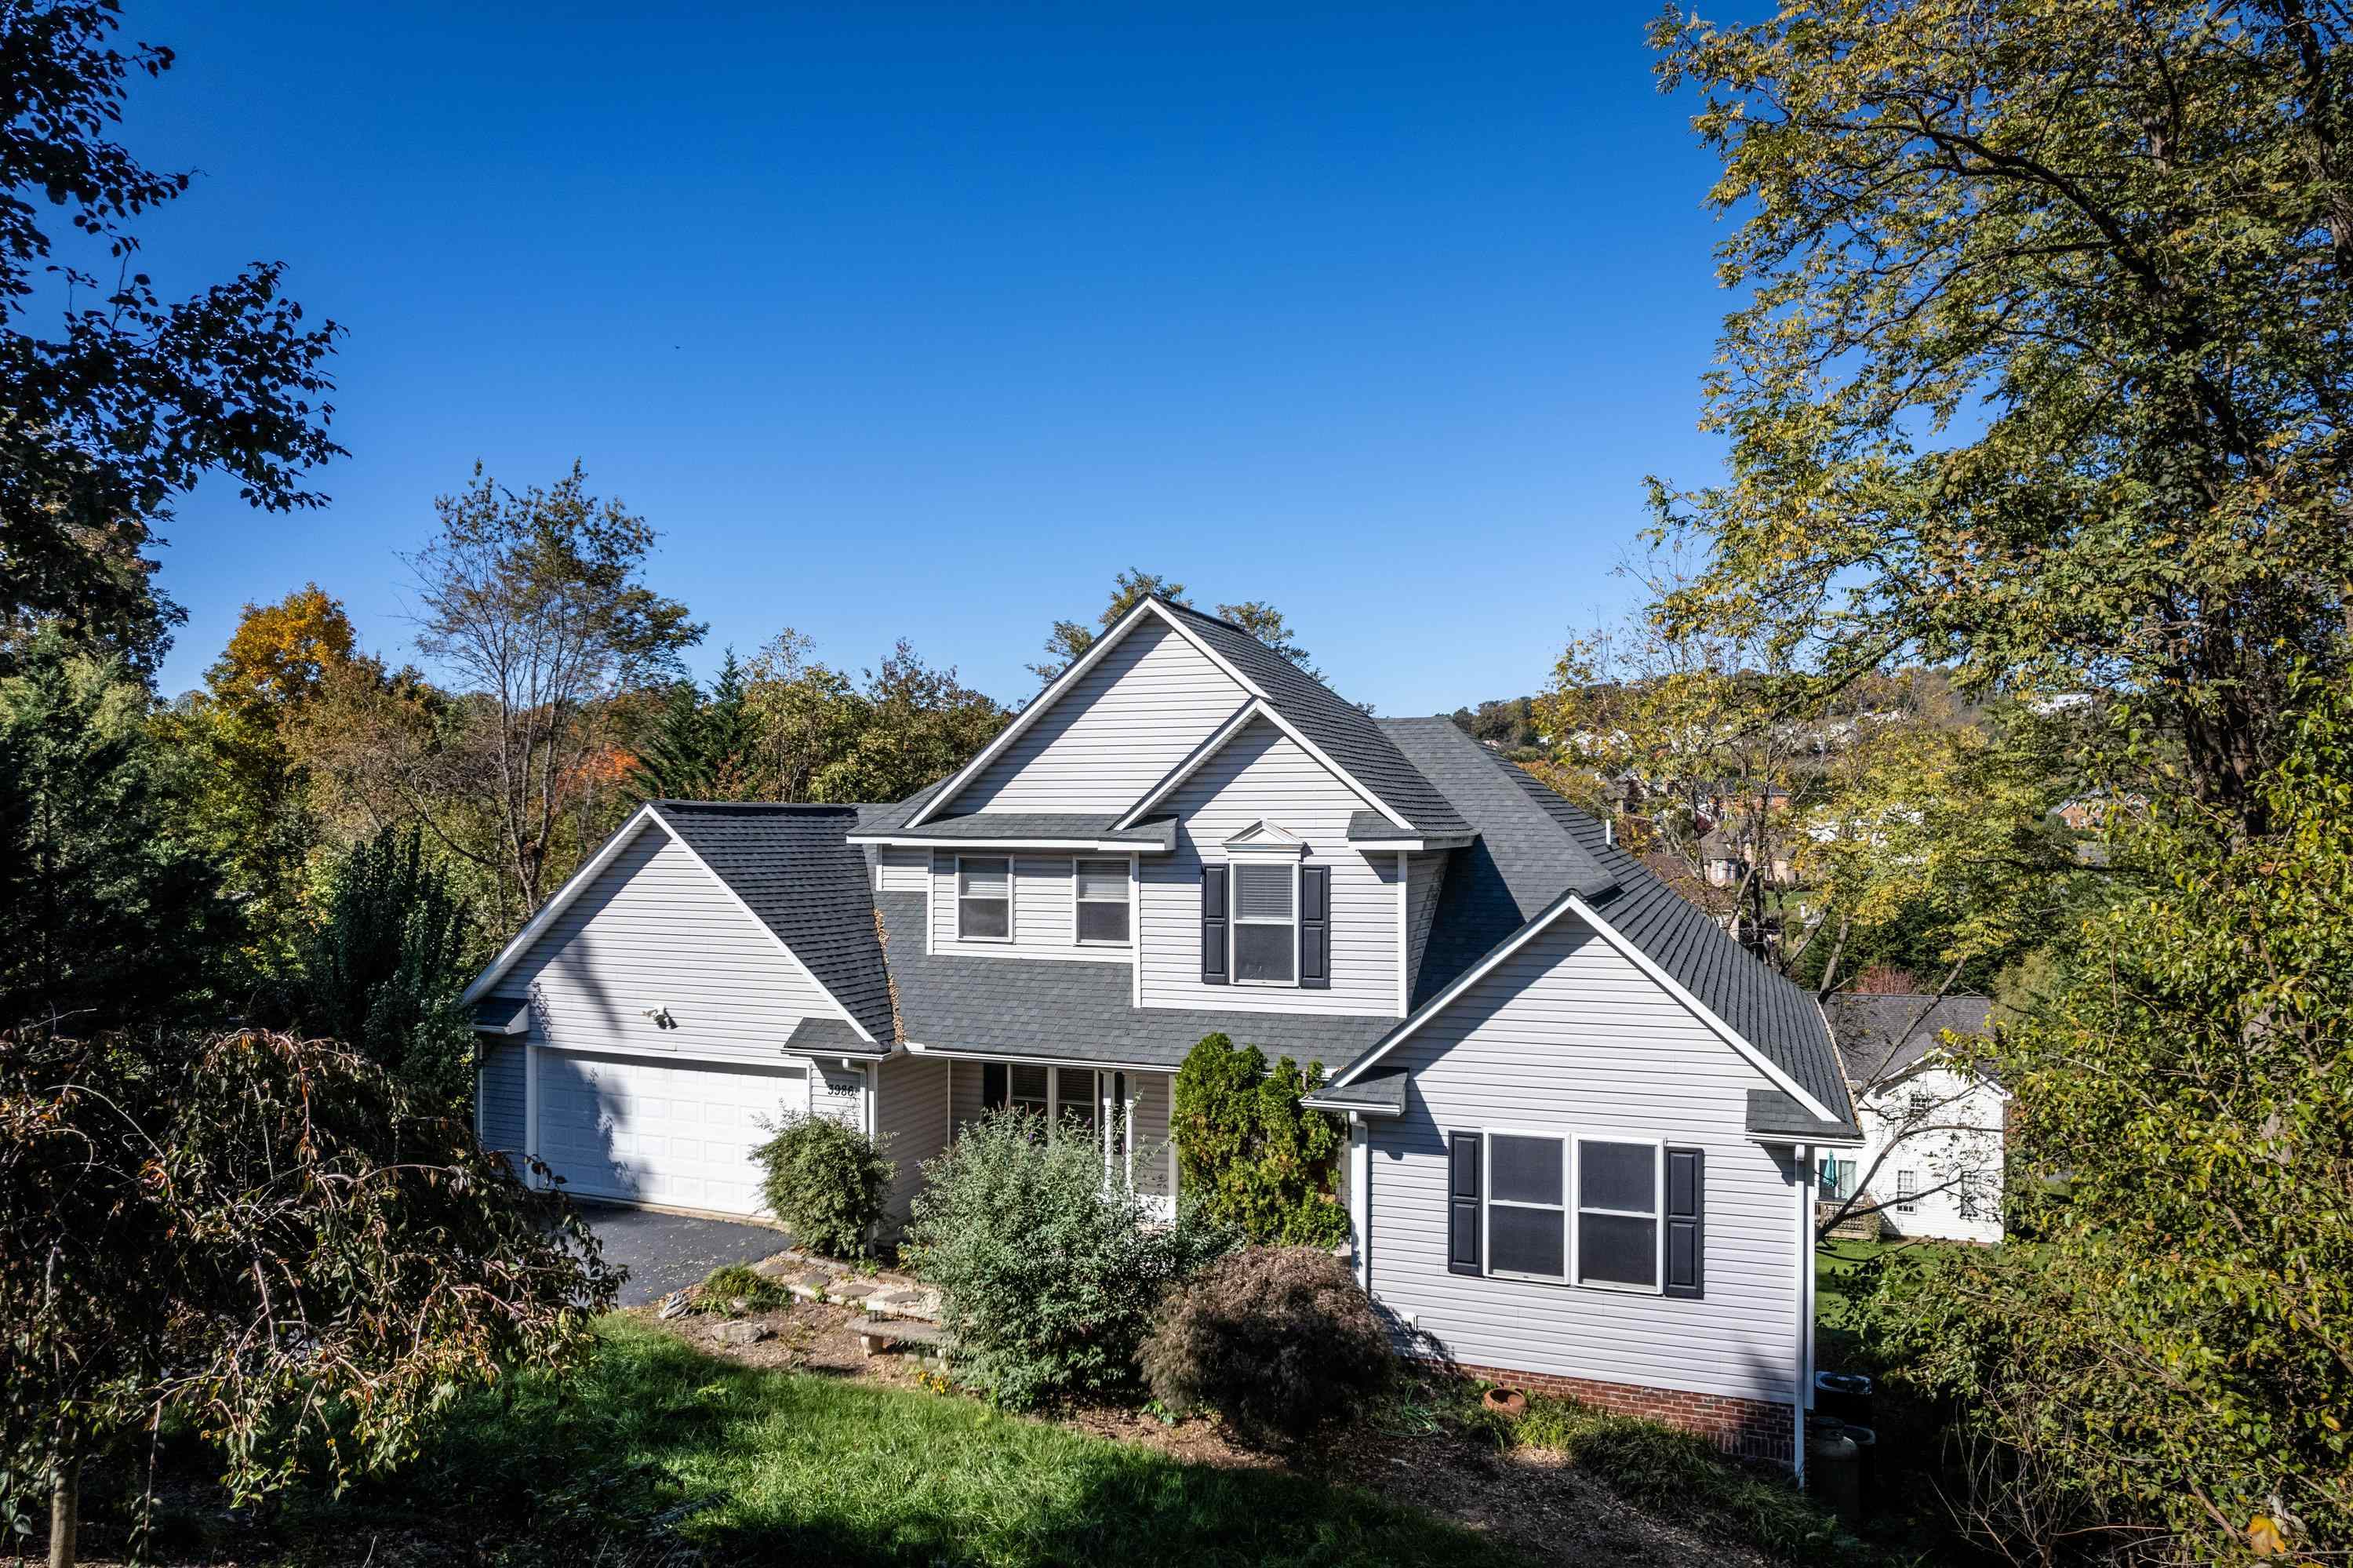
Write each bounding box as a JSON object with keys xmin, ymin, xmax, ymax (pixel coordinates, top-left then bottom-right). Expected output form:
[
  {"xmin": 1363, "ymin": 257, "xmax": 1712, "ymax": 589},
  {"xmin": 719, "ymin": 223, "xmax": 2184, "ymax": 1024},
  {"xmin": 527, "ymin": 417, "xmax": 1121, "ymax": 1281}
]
[{"xmin": 1144, "ymin": 1248, "xmax": 1395, "ymax": 1441}]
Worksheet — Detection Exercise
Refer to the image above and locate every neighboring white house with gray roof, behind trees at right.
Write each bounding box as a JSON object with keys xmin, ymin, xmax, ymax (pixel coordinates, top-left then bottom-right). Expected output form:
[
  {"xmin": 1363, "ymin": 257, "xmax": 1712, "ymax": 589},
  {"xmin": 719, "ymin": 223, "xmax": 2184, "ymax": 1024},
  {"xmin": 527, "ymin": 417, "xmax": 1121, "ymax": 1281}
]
[{"xmin": 1821, "ymin": 994, "xmax": 2009, "ymax": 1241}]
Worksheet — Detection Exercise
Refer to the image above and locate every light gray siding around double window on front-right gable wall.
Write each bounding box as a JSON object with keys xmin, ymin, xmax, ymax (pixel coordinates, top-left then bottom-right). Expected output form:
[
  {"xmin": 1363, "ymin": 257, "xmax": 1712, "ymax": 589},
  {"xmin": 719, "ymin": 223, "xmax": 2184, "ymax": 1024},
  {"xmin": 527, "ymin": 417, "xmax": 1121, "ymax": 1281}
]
[{"xmin": 1369, "ymin": 919, "xmax": 1798, "ymax": 1401}]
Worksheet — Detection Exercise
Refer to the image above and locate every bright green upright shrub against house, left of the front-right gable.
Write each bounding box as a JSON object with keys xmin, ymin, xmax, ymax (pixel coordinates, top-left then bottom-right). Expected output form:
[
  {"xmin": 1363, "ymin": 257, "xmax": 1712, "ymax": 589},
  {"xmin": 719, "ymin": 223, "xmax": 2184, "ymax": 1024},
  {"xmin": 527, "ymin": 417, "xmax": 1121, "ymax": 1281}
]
[{"xmin": 1169, "ymin": 1034, "xmax": 1348, "ymax": 1248}]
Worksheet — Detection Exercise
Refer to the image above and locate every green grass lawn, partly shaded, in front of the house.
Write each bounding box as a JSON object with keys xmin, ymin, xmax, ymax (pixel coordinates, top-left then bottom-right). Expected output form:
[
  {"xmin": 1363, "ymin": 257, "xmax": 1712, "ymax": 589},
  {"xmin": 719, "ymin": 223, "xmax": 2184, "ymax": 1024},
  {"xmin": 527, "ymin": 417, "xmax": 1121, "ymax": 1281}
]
[{"xmin": 216, "ymin": 1319, "xmax": 1520, "ymax": 1568}]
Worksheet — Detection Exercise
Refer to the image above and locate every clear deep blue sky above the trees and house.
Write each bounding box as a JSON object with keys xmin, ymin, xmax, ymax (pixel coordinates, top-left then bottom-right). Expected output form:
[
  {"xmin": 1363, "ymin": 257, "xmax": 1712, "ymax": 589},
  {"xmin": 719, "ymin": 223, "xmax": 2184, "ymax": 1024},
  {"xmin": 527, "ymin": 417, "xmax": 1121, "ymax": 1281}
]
[{"xmin": 125, "ymin": 0, "xmax": 1727, "ymax": 713}]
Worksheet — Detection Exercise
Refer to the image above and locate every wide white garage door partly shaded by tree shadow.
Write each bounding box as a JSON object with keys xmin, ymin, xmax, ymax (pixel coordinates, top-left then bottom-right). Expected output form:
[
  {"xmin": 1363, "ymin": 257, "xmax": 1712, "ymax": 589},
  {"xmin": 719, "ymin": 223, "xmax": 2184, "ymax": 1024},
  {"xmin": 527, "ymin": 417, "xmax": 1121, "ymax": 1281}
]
[{"xmin": 539, "ymin": 1050, "xmax": 809, "ymax": 1215}]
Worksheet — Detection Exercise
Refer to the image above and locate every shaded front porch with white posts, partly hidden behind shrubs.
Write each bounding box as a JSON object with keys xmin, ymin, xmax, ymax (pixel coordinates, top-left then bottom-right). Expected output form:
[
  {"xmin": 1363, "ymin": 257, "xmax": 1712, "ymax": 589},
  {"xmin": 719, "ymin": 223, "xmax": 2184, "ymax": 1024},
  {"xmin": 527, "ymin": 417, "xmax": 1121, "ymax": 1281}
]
[{"xmin": 946, "ymin": 1057, "xmax": 1176, "ymax": 1220}]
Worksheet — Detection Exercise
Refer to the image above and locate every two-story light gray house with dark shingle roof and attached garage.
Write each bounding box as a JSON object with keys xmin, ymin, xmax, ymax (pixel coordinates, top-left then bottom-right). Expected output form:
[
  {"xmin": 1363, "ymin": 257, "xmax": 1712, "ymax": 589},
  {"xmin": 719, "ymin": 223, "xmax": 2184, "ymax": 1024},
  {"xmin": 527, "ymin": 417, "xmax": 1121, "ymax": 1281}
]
[{"xmin": 471, "ymin": 600, "xmax": 1859, "ymax": 1457}]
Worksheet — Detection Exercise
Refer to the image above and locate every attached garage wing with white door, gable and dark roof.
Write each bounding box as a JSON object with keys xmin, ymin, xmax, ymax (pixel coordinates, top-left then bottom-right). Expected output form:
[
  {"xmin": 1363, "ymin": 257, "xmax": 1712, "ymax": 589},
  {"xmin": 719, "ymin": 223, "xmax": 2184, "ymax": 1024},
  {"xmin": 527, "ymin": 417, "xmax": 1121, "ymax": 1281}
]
[{"xmin": 468, "ymin": 801, "xmax": 894, "ymax": 1215}]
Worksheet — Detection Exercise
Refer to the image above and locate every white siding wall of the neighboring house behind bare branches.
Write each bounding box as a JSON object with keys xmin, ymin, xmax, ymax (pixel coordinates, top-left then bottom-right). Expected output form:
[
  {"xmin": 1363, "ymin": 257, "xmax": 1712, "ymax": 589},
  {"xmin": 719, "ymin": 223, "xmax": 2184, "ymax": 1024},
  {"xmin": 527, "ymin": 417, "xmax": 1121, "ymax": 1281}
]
[{"xmin": 1835, "ymin": 1067, "xmax": 2005, "ymax": 1241}]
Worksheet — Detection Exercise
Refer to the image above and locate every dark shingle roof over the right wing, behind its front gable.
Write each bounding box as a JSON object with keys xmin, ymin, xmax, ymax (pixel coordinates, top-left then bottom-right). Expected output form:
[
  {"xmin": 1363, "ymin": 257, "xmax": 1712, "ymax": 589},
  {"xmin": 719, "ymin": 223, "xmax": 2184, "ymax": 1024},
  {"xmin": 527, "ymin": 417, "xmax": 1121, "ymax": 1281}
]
[{"xmin": 1381, "ymin": 718, "xmax": 1852, "ymax": 1116}]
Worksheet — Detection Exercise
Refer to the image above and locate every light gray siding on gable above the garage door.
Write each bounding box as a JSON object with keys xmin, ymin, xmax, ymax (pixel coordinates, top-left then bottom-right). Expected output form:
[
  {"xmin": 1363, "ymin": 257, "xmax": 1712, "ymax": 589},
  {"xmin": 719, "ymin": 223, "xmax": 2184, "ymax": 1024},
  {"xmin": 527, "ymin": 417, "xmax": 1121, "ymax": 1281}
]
[{"xmin": 494, "ymin": 822, "xmax": 840, "ymax": 1062}]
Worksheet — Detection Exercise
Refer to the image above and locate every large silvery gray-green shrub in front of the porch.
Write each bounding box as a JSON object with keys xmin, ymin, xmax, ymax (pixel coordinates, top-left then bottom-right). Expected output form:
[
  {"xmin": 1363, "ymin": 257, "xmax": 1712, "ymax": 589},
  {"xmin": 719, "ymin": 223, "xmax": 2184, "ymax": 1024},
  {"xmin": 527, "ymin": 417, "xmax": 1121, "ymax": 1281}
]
[{"xmin": 906, "ymin": 1111, "xmax": 1231, "ymax": 1408}]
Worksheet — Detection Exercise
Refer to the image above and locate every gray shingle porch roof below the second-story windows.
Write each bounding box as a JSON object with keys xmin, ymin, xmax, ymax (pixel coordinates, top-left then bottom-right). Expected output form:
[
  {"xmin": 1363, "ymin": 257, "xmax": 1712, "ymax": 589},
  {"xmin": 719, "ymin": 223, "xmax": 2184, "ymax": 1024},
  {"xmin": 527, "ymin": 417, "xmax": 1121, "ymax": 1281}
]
[{"xmin": 875, "ymin": 893, "xmax": 1398, "ymax": 1067}]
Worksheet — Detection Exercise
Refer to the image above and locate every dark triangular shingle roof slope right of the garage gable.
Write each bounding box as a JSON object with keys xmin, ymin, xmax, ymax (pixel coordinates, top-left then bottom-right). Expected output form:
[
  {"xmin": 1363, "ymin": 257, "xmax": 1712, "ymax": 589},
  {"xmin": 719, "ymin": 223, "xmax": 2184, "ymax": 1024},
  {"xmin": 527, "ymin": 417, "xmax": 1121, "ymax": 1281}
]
[{"xmin": 652, "ymin": 801, "xmax": 894, "ymax": 1048}]
